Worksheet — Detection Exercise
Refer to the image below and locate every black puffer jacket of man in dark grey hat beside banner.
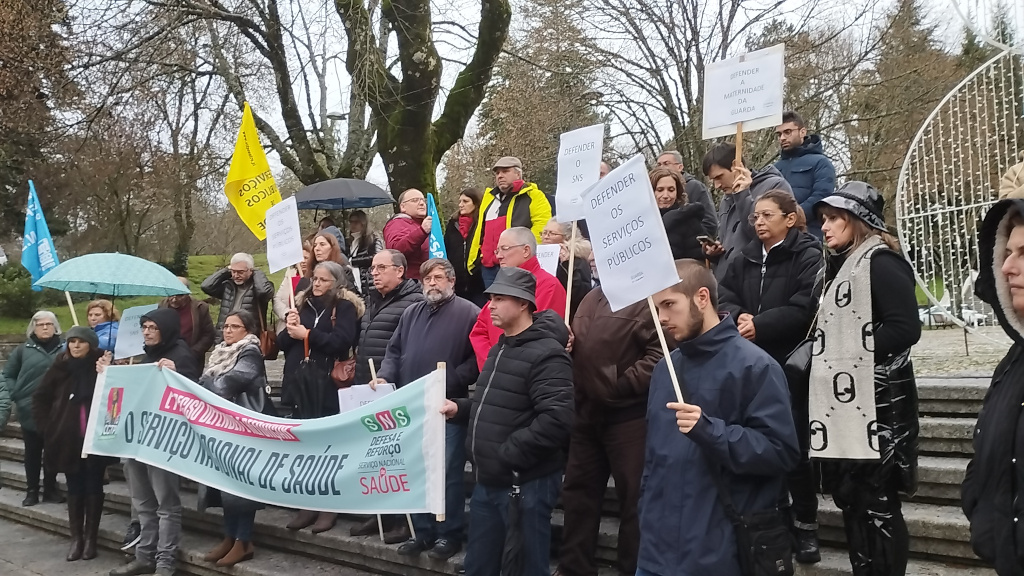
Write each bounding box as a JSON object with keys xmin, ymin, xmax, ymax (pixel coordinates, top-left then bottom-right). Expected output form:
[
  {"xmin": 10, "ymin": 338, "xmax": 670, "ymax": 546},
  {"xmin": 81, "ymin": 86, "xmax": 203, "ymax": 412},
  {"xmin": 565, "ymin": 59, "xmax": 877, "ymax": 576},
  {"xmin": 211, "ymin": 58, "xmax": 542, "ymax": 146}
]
[{"xmin": 456, "ymin": 311, "xmax": 573, "ymax": 488}]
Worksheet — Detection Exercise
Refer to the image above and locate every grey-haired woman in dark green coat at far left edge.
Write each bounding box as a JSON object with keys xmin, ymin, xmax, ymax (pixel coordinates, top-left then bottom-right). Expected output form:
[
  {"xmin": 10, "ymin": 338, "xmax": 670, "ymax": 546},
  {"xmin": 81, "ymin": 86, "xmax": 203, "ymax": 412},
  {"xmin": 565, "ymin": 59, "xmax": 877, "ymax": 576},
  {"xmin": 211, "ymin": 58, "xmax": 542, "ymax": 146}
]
[{"xmin": 3, "ymin": 310, "xmax": 63, "ymax": 506}]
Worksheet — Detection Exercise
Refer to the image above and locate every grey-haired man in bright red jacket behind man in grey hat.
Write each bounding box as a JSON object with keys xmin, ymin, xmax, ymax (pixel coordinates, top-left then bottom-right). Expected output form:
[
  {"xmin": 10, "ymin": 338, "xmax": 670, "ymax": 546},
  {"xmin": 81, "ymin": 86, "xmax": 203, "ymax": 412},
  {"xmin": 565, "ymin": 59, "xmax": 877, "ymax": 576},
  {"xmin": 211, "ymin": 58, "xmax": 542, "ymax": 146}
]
[{"xmin": 469, "ymin": 227, "xmax": 565, "ymax": 370}]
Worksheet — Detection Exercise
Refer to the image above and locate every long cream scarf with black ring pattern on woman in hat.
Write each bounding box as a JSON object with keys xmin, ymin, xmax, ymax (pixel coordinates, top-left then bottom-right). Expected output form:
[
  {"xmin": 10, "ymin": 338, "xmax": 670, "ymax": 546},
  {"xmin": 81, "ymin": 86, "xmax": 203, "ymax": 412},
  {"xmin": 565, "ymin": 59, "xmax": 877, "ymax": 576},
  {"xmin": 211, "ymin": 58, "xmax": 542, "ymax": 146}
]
[{"xmin": 808, "ymin": 236, "xmax": 885, "ymax": 460}]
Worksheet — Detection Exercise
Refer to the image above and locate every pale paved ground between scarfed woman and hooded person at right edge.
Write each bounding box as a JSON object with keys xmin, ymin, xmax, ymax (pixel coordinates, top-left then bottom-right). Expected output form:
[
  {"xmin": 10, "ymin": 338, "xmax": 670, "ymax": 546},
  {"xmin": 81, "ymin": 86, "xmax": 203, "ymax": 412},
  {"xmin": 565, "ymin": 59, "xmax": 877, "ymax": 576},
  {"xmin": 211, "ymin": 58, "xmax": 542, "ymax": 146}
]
[{"xmin": 912, "ymin": 326, "xmax": 1011, "ymax": 376}]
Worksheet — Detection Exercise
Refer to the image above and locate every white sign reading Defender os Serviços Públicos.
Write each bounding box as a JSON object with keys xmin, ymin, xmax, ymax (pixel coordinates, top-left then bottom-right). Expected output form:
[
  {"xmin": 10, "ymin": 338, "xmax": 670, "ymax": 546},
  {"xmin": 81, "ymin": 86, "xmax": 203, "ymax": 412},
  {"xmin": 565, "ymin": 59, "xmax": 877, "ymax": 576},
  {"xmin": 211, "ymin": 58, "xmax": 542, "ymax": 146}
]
[{"xmin": 583, "ymin": 155, "xmax": 679, "ymax": 312}]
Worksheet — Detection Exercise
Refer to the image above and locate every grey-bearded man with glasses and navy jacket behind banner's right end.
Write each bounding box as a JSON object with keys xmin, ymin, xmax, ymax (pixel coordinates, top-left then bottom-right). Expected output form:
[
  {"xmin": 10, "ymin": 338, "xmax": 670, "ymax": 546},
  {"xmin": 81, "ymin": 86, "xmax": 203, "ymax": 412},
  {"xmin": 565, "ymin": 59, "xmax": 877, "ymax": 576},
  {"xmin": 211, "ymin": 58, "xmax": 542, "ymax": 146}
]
[{"xmin": 371, "ymin": 258, "xmax": 480, "ymax": 560}]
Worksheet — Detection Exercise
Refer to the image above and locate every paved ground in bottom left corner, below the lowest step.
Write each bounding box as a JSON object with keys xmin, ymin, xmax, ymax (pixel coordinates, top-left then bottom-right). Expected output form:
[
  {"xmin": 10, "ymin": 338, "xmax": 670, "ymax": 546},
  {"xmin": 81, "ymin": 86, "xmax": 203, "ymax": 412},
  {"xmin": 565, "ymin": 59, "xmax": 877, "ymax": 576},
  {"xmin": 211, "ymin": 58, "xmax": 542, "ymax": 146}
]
[{"xmin": 0, "ymin": 520, "xmax": 125, "ymax": 576}]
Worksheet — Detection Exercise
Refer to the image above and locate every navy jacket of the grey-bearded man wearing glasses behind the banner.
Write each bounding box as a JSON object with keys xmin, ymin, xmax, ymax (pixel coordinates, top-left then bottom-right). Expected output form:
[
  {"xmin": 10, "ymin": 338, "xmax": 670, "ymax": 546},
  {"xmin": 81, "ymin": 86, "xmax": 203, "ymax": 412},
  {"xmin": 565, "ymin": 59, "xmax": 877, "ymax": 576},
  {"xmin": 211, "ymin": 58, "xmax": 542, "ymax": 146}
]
[{"xmin": 377, "ymin": 296, "xmax": 480, "ymax": 399}]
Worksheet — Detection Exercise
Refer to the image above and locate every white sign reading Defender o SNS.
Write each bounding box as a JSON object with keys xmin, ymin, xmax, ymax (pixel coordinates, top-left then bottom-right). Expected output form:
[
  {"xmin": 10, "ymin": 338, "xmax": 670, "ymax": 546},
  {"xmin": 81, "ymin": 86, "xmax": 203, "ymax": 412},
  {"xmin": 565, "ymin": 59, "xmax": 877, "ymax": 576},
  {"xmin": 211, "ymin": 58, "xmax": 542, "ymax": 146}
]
[{"xmin": 555, "ymin": 124, "xmax": 604, "ymax": 222}]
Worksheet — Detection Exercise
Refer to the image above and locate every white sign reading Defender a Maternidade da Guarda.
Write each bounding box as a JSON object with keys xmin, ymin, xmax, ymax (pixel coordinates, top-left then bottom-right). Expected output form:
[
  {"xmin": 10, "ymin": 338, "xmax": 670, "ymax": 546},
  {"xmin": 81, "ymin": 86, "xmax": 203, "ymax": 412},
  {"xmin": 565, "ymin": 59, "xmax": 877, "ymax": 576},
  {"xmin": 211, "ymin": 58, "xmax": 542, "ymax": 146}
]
[{"xmin": 702, "ymin": 44, "xmax": 785, "ymax": 139}]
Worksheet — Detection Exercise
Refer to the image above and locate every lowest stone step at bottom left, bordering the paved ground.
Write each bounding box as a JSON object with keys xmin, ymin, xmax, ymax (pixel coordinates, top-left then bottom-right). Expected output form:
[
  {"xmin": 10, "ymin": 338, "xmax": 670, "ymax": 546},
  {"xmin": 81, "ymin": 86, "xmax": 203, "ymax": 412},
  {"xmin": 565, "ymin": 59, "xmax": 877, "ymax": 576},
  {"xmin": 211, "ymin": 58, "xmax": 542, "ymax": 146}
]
[{"xmin": 0, "ymin": 481, "xmax": 369, "ymax": 576}]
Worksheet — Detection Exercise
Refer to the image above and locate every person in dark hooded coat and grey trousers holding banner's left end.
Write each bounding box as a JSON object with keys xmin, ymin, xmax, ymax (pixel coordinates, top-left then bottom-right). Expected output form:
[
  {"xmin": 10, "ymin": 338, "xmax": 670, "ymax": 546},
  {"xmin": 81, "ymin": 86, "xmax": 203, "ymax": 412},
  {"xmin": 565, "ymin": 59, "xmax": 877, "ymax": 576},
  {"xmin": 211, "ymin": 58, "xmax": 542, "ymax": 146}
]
[{"xmin": 111, "ymin": 308, "xmax": 201, "ymax": 576}]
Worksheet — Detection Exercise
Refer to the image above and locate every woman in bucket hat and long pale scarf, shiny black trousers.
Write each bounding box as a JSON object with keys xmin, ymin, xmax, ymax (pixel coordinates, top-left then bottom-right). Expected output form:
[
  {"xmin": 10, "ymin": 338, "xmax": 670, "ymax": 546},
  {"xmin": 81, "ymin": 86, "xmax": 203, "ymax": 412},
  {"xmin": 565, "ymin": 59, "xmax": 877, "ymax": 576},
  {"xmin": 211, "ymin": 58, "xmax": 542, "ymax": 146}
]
[{"xmin": 808, "ymin": 181, "xmax": 921, "ymax": 576}]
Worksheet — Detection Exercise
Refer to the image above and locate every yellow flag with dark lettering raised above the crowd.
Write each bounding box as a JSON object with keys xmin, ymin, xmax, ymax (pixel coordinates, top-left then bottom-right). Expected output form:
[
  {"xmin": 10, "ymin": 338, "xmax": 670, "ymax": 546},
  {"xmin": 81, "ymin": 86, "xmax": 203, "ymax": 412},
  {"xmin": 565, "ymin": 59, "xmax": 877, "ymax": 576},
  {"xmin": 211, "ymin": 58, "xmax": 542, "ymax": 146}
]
[{"xmin": 224, "ymin": 102, "xmax": 281, "ymax": 240}]
